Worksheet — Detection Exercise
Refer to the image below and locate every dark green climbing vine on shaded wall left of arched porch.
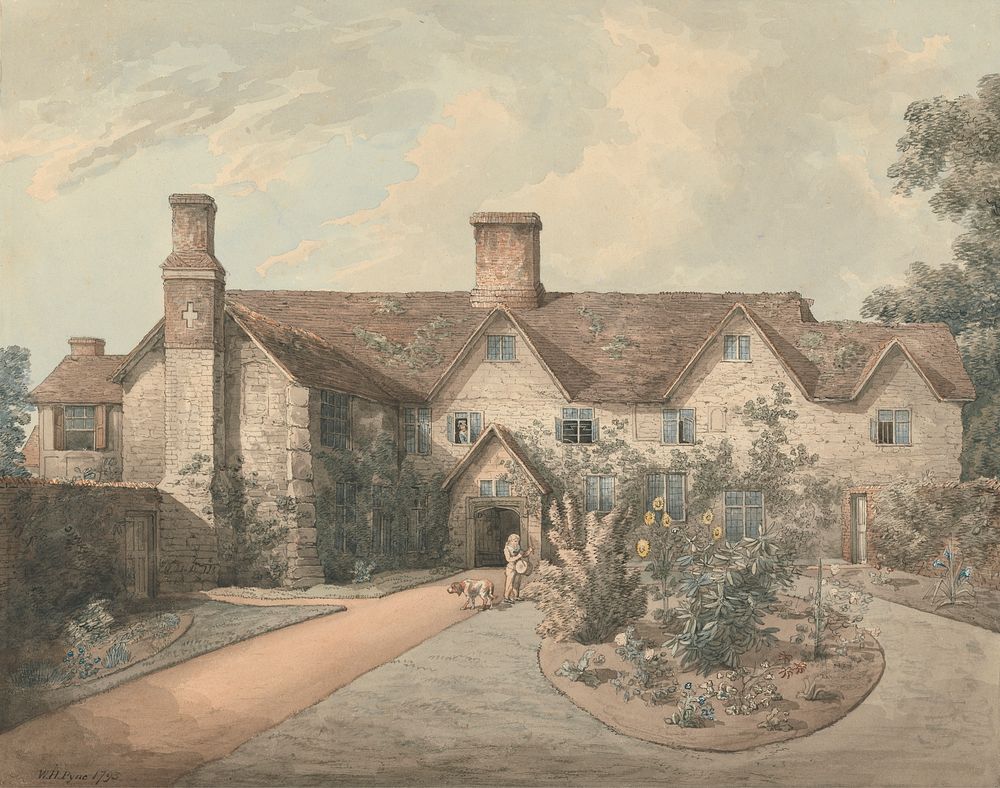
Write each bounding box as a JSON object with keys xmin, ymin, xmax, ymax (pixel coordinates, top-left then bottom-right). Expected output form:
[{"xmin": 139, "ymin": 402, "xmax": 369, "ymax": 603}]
[{"xmin": 316, "ymin": 434, "xmax": 450, "ymax": 581}]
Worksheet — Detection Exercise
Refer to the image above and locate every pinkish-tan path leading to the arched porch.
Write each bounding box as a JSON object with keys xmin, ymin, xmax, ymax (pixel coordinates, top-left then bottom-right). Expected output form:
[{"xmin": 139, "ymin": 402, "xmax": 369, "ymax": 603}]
[{"xmin": 0, "ymin": 570, "xmax": 502, "ymax": 786}]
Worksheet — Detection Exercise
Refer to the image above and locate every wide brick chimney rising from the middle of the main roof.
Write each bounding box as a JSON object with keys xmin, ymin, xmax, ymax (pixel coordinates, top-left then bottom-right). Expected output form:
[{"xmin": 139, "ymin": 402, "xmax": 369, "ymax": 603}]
[{"xmin": 469, "ymin": 211, "xmax": 545, "ymax": 309}]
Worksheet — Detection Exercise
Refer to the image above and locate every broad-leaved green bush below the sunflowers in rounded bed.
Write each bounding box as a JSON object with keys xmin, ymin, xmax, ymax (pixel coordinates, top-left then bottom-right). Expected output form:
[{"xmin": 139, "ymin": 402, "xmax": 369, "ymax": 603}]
[{"xmin": 667, "ymin": 533, "xmax": 794, "ymax": 676}]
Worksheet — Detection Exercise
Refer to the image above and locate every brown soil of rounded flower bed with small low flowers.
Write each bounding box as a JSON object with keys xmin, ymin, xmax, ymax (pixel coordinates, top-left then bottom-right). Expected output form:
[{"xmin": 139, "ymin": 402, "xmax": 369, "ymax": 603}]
[{"xmin": 538, "ymin": 605, "xmax": 885, "ymax": 752}]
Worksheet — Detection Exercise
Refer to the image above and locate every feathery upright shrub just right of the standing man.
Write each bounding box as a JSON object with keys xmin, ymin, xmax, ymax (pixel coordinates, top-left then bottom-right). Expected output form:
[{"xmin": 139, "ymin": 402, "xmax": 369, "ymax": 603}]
[{"xmin": 531, "ymin": 495, "xmax": 646, "ymax": 644}]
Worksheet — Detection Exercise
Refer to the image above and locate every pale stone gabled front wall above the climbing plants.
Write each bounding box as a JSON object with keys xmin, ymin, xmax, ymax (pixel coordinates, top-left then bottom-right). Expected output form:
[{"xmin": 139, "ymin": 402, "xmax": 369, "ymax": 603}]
[{"xmin": 414, "ymin": 315, "xmax": 962, "ymax": 556}]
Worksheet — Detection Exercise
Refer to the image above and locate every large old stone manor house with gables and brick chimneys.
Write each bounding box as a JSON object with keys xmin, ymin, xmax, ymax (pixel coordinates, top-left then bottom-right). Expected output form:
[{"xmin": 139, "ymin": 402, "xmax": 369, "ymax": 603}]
[{"xmin": 28, "ymin": 194, "xmax": 975, "ymax": 590}]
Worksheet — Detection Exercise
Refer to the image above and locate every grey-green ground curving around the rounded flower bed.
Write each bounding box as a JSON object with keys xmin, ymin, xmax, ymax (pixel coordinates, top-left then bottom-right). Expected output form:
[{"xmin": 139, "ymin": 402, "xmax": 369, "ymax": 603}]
[{"xmin": 181, "ymin": 600, "xmax": 1000, "ymax": 786}]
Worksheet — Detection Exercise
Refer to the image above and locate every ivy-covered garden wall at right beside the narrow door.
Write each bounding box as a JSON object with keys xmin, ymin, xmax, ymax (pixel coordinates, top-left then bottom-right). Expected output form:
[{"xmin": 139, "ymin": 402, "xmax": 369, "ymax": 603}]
[{"xmin": 843, "ymin": 479, "xmax": 1000, "ymax": 588}]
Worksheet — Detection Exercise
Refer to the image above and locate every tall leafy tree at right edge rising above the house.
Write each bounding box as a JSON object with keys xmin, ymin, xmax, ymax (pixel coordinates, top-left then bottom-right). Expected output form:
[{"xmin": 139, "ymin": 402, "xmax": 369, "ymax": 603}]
[{"xmin": 862, "ymin": 74, "xmax": 1000, "ymax": 478}]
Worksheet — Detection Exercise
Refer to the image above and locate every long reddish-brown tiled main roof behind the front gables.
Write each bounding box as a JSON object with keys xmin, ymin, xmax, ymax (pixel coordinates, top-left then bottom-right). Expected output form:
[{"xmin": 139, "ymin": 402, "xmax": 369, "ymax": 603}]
[{"xmin": 227, "ymin": 290, "xmax": 975, "ymax": 402}]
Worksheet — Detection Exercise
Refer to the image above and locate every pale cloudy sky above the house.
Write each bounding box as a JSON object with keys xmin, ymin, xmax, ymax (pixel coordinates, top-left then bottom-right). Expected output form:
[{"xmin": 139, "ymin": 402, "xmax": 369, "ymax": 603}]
[{"xmin": 0, "ymin": 0, "xmax": 1000, "ymax": 382}]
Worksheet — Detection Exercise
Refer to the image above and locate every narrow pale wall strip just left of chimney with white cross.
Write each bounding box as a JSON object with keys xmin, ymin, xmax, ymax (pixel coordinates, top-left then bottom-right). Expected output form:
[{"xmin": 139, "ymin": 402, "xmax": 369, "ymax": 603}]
[{"xmin": 122, "ymin": 346, "xmax": 166, "ymax": 484}]
